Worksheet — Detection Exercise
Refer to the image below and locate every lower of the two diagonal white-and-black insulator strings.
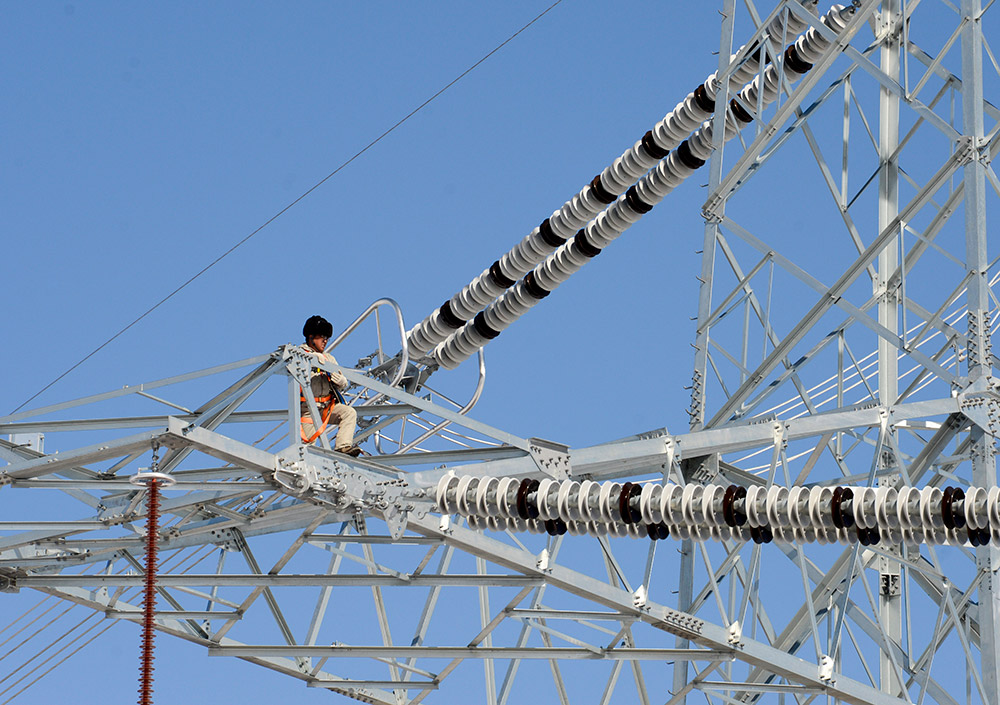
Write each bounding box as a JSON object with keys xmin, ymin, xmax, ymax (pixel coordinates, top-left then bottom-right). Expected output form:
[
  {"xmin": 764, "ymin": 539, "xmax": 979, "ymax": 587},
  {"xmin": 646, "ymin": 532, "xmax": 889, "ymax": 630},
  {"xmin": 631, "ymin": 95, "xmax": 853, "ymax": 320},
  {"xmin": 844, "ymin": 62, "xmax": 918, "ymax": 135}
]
[{"xmin": 434, "ymin": 5, "xmax": 856, "ymax": 369}]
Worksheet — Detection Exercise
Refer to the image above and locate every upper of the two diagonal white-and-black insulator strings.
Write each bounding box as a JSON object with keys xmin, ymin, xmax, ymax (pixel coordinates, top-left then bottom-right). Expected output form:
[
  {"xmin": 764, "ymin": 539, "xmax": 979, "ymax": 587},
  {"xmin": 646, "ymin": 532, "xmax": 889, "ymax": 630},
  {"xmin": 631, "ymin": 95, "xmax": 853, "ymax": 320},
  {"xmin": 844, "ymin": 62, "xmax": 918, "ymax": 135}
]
[{"xmin": 407, "ymin": 0, "xmax": 818, "ymax": 355}]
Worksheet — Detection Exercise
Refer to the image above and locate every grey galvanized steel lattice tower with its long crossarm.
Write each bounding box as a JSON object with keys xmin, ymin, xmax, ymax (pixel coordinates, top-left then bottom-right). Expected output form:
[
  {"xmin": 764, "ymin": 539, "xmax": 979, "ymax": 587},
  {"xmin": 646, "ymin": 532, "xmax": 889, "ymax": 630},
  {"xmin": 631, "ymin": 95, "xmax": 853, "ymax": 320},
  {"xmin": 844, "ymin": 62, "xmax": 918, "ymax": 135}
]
[{"xmin": 0, "ymin": 0, "xmax": 1000, "ymax": 705}]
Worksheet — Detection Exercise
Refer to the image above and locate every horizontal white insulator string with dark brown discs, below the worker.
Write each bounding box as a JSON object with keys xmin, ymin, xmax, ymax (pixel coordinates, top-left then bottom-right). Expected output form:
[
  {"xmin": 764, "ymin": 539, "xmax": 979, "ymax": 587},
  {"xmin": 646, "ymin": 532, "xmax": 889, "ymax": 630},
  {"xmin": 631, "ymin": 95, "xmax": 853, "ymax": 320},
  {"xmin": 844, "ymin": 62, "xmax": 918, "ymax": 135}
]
[{"xmin": 436, "ymin": 475, "xmax": 1000, "ymax": 546}]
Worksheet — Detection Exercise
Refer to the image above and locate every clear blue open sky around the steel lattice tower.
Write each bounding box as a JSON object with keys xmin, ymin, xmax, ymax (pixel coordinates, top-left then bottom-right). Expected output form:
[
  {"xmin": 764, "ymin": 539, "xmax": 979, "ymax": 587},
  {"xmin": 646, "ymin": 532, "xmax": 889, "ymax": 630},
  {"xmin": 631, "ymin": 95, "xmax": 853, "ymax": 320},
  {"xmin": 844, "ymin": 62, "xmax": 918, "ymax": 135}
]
[{"xmin": 0, "ymin": 0, "xmax": 996, "ymax": 705}]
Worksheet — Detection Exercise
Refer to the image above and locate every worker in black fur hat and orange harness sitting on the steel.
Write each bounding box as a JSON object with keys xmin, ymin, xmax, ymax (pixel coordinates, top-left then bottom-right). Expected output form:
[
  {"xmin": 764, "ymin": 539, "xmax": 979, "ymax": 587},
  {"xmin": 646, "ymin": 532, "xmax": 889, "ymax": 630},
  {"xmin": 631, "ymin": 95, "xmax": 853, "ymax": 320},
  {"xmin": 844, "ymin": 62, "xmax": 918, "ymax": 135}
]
[{"xmin": 299, "ymin": 316, "xmax": 361, "ymax": 458}]
